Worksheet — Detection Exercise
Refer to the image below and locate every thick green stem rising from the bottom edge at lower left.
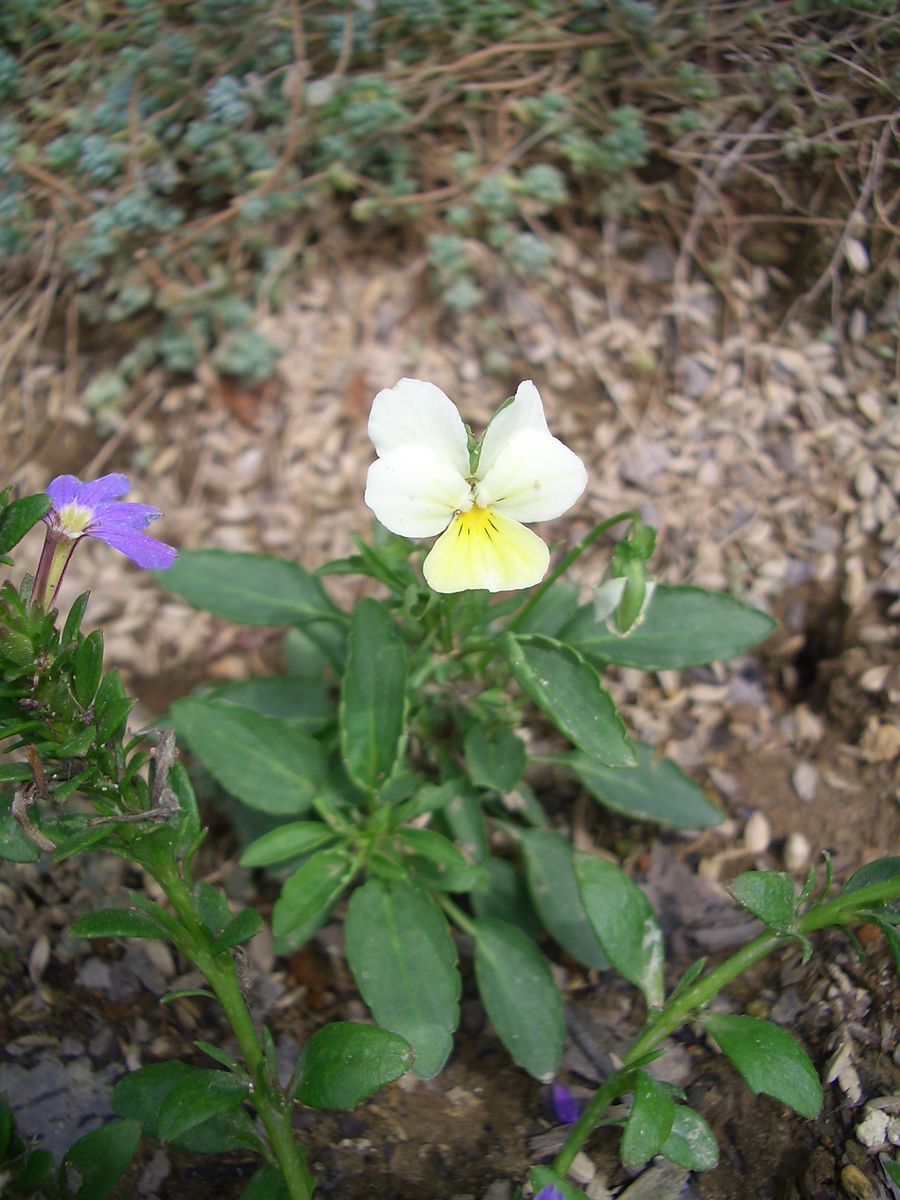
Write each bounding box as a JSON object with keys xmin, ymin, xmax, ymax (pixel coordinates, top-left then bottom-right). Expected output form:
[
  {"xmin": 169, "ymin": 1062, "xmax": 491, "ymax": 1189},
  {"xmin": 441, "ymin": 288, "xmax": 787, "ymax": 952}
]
[{"xmin": 160, "ymin": 864, "xmax": 314, "ymax": 1200}]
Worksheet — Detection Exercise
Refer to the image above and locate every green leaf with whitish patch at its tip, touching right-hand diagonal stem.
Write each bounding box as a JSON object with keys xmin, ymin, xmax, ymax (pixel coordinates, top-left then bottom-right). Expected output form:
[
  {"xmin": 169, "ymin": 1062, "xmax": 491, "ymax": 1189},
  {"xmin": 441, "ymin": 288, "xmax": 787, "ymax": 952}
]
[{"xmin": 572, "ymin": 851, "xmax": 664, "ymax": 1008}]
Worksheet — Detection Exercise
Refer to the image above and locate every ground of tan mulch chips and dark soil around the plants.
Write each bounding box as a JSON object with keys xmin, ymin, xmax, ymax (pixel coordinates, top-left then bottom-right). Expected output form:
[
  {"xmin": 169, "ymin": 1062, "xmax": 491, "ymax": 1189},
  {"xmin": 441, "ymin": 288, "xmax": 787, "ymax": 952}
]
[{"xmin": 0, "ymin": 234, "xmax": 900, "ymax": 1200}]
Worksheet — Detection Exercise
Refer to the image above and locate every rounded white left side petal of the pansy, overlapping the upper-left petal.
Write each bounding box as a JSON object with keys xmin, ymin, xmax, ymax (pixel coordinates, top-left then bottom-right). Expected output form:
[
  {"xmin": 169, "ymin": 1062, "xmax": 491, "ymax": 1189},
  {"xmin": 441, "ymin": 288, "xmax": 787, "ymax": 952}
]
[{"xmin": 366, "ymin": 446, "xmax": 472, "ymax": 538}]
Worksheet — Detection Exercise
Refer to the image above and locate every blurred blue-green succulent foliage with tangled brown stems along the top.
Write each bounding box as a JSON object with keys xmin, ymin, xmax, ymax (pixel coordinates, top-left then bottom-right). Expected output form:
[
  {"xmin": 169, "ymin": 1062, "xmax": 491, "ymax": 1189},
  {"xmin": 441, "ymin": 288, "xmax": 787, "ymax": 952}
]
[{"xmin": 0, "ymin": 0, "xmax": 899, "ymax": 379}]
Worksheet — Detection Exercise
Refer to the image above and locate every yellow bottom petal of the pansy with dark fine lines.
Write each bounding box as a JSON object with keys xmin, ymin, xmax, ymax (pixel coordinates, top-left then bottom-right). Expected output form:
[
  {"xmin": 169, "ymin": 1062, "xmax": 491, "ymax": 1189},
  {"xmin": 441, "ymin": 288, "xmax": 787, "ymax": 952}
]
[{"xmin": 424, "ymin": 509, "xmax": 550, "ymax": 592}]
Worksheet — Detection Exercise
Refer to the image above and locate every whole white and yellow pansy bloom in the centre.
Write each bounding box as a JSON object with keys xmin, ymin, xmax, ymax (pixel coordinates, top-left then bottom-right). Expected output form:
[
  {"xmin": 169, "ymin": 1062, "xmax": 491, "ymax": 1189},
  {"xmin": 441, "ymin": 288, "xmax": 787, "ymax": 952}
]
[{"xmin": 366, "ymin": 379, "xmax": 588, "ymax": 592}]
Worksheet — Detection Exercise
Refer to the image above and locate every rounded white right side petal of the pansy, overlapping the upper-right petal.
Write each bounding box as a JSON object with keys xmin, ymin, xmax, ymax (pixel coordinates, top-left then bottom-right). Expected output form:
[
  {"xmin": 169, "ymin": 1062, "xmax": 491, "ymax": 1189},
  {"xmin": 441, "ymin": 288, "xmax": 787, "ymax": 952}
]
[{"xmin": 475, "ymin": 430, "xmax": 588, "ymax": 522}]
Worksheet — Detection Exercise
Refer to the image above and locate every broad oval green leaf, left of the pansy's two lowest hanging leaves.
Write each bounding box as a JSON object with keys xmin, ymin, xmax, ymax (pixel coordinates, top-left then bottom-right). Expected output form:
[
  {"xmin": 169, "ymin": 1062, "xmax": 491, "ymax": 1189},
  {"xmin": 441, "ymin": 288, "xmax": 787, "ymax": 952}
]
[{"xmin": 344, "ymin": 880, "xmax": 461, "ymax": 1079}]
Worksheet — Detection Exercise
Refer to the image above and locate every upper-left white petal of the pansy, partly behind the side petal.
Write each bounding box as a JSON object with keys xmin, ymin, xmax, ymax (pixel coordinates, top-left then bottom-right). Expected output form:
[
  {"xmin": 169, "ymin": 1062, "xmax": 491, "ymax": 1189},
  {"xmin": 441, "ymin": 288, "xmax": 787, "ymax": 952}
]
[{"xmin": 368, "ymin": 379, "xmax": 469, "ymax": 475}]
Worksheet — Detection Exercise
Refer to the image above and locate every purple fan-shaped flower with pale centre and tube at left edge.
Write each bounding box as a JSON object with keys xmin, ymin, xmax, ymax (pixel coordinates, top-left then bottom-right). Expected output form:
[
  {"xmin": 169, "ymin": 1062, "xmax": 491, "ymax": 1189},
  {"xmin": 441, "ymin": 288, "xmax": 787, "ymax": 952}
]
[{"xmin": 34, "ymin": 465, "xmax": 178, "ymax": 604}]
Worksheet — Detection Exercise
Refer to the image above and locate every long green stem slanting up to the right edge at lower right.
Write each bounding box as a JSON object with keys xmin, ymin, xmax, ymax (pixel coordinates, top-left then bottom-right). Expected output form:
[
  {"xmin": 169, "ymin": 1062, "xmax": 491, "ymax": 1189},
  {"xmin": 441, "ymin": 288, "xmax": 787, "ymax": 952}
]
[{"xmin": 553, "ymin": 877, "xmax": 900, "ymax": 1175}]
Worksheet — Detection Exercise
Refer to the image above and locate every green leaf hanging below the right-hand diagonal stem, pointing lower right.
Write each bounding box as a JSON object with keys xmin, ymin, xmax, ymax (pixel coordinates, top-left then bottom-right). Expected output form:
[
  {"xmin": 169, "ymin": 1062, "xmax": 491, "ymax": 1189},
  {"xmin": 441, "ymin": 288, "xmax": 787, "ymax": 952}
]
[{"xmin": 703, "ymin": 1013, "xmax": 822, "ymax": 1118}]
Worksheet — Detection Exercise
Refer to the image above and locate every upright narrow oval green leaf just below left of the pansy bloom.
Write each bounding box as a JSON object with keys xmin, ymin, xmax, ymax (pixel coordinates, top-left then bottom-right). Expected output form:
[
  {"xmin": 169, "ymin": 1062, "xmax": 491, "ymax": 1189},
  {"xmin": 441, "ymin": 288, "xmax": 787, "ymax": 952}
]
[{"xmin": 340, "ymin": 599, "xmax": 407, "ymax": 792}]
